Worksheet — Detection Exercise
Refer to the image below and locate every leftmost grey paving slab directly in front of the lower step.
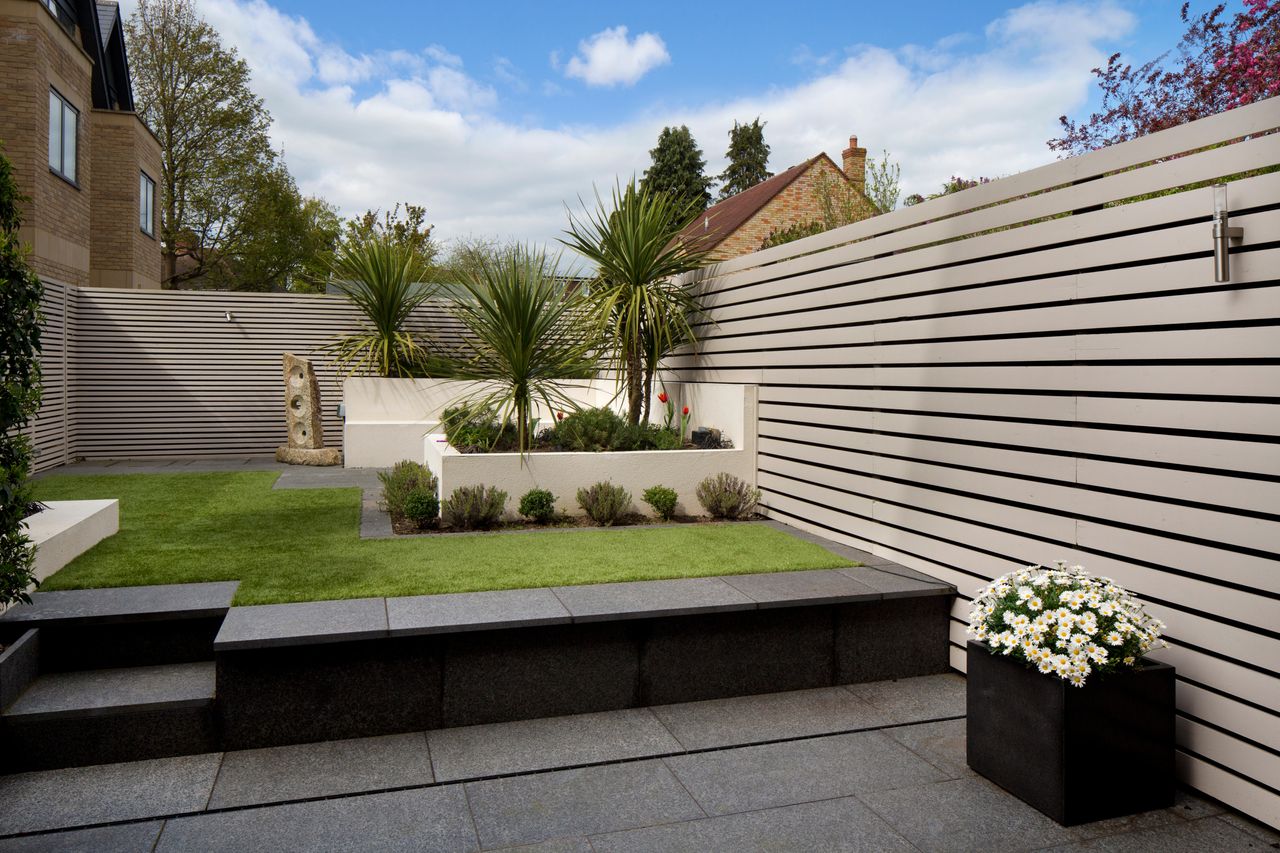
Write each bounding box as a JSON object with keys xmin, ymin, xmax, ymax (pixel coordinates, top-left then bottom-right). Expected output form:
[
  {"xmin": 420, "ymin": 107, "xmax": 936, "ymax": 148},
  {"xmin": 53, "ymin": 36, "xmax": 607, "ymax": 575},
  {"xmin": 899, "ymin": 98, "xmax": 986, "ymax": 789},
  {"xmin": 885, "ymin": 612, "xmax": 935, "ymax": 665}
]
[{"xmin": 0, "ymin": 753, "xmax": 221, "ymax": 834}]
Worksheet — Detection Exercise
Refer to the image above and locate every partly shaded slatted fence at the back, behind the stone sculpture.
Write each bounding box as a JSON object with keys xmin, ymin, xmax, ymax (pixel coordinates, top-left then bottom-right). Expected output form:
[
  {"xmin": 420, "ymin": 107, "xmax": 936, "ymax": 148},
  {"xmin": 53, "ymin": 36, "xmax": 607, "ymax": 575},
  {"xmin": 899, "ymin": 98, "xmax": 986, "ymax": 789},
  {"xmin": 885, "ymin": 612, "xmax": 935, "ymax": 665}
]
[{"xmin": 37, "ymin": 288, "xmax": 468, "ymax": 459}]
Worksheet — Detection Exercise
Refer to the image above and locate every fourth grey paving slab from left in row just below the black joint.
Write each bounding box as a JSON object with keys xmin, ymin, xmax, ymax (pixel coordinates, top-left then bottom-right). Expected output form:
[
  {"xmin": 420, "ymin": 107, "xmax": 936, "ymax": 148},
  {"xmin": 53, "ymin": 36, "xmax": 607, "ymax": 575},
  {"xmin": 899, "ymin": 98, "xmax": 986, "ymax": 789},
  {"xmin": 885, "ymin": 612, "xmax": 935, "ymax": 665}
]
[{"xmin": 663, "ymin": 731, "xmax": 946, "ymax": 815}]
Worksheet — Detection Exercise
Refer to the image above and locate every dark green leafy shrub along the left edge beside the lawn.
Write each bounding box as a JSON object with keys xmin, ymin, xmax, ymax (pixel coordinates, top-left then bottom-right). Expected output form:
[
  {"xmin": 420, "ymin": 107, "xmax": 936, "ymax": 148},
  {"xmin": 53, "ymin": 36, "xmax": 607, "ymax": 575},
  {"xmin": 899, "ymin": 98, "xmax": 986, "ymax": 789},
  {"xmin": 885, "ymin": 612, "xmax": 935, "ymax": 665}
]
[{"xmin": 0, "ymin": 143, "xmax": 44, "ymax": 605}]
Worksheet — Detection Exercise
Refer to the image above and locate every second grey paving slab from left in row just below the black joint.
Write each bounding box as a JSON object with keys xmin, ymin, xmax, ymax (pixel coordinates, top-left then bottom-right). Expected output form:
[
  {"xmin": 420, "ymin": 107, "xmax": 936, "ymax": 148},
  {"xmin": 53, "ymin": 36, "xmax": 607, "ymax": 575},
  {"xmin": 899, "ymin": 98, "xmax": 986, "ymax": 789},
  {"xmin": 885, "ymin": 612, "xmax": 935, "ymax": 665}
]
[{"xmin": 156, "ymin": 785, "xmax": 477, "ymax": 853}]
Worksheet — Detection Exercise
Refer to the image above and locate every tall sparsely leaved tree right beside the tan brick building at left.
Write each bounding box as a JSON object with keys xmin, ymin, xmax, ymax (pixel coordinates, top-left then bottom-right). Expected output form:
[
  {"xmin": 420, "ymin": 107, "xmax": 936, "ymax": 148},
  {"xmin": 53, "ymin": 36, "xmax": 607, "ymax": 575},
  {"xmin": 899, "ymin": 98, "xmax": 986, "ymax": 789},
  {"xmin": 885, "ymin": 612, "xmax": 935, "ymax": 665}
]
[{"xmin": 125, "ymin": 0, "xmax": 276, "ymax": 286}]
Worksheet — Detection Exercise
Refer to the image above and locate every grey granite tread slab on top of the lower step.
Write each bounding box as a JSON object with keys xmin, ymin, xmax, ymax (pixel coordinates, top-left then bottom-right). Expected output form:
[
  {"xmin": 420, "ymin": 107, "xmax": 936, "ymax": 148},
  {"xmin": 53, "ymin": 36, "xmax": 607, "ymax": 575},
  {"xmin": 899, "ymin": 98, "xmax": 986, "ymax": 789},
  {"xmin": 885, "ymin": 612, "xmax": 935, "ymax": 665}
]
[{"xmin": 4, "ymin": 661, "xmax": 215, "ymax": 720}]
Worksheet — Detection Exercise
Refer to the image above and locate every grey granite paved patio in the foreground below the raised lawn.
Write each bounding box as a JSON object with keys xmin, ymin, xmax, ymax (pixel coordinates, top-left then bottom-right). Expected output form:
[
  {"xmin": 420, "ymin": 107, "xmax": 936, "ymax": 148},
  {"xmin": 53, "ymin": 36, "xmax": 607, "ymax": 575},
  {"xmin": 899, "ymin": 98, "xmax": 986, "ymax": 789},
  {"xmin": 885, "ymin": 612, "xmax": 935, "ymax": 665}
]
[{"xmin": 0, "ymin": 674, "xmax": 1280, "ymax": 853}]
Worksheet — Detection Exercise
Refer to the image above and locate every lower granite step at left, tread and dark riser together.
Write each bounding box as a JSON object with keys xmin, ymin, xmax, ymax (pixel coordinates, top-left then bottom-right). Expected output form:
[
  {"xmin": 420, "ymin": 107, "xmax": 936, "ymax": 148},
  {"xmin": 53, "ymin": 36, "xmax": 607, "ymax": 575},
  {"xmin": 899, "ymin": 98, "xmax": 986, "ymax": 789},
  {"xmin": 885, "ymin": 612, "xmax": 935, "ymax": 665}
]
[{"xmin": 0, "ymin": 661, "xmax": 218, "ymax": 772}]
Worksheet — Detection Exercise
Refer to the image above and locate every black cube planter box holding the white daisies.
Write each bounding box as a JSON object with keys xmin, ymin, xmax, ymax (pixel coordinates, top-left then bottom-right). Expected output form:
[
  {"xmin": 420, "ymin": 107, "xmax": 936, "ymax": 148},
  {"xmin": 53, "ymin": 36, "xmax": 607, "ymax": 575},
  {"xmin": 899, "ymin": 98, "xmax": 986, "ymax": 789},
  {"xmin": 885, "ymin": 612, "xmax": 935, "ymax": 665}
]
[{"xmin": 966, "ymin": 640, "xmax": 1174, "ymax": 826}]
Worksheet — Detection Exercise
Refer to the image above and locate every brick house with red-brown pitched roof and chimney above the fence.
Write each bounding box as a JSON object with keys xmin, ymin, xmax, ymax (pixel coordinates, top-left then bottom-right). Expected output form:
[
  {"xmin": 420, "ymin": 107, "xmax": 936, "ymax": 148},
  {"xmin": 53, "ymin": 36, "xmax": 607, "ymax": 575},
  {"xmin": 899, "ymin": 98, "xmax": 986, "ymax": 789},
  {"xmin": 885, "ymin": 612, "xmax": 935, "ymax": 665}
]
[{"xmin": 681, "ymin": 136, "xmax": 870, "ymax": 260}]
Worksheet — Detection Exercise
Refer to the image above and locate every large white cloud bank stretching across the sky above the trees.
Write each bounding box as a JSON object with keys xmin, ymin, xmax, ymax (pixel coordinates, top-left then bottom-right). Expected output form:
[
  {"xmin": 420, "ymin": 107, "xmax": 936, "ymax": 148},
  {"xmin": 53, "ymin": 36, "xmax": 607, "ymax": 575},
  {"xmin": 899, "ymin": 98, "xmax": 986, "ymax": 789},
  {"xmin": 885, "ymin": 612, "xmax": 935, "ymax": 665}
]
[{"xmin": 167, "ymin": 0, "xmax": 1133, "ymax": 249}]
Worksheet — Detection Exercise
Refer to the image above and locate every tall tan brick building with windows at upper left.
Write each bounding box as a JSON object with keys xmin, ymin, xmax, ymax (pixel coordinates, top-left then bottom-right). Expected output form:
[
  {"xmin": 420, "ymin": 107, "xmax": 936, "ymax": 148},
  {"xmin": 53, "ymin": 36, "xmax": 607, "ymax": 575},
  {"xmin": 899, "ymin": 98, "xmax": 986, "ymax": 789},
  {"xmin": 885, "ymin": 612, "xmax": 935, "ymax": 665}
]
[{"xmin": 0, "ymin": 0, "xmax": 160, "ymax": 288}]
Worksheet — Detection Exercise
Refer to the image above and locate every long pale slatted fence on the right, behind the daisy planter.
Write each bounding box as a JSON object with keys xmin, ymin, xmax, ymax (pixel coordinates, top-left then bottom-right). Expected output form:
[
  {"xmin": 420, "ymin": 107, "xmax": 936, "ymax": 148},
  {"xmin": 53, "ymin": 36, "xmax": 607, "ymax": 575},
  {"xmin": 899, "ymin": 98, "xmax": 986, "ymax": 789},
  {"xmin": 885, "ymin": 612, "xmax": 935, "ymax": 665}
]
[{"xmin": 671, "ymin": 99, "xmax": 1280, "ymax": 825}]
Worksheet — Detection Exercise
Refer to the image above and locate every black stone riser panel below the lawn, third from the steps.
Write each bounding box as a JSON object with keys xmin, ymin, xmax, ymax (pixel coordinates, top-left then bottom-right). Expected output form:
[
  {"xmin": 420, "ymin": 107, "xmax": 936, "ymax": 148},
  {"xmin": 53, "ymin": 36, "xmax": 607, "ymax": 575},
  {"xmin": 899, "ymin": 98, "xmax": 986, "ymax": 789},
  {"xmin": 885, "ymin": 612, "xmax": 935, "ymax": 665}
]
[{"xmin": 640, "ymin": 607, "xmax": 832, "ymax": 704}]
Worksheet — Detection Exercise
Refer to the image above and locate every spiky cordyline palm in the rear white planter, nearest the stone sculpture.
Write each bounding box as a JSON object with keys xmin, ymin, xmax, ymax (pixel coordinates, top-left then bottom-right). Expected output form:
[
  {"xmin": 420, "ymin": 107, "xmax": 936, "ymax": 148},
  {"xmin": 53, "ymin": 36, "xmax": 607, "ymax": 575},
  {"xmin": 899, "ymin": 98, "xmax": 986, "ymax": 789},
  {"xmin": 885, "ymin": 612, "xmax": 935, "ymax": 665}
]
[{"xmin": 325, "ymin": 236, "xmax": 434, "ymax": 377}]
